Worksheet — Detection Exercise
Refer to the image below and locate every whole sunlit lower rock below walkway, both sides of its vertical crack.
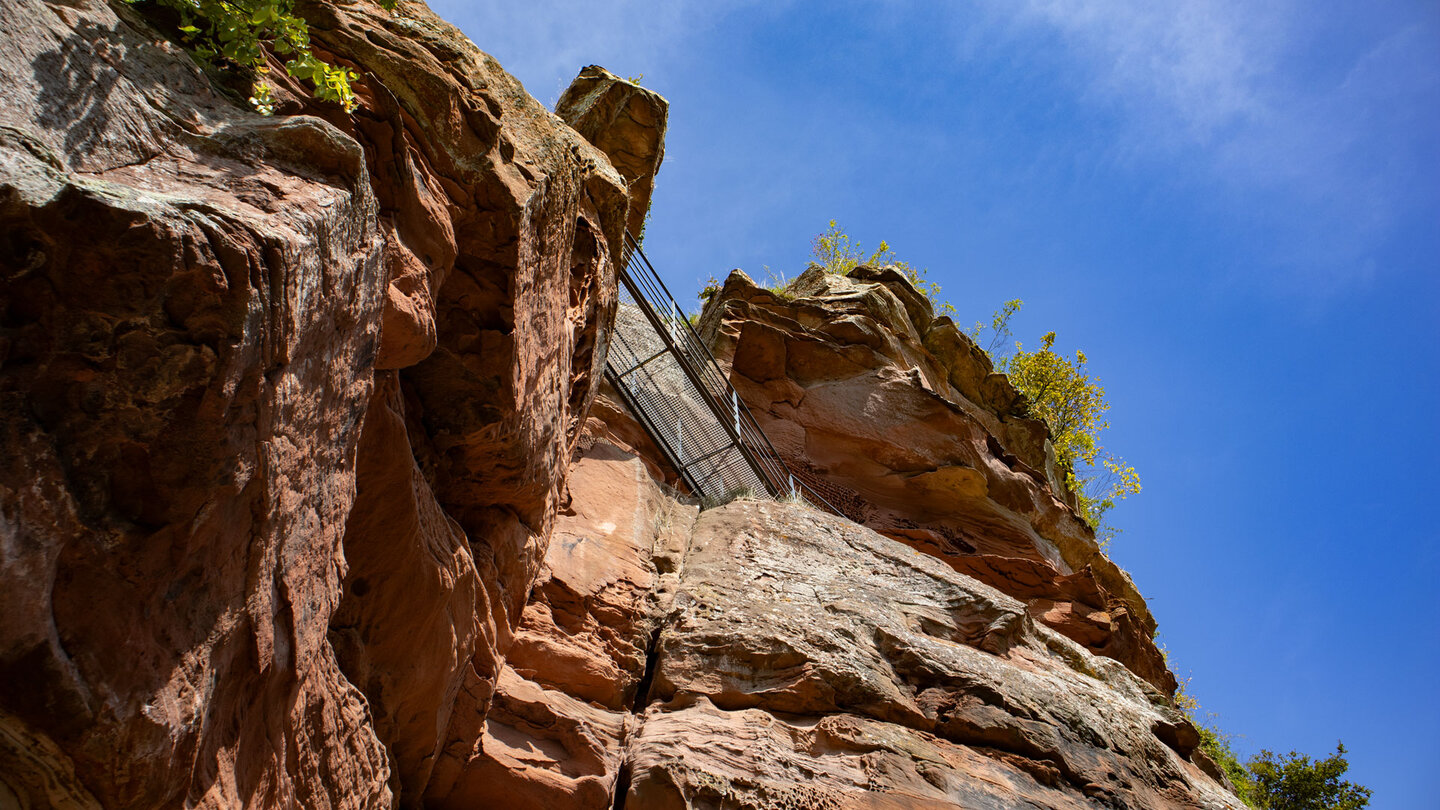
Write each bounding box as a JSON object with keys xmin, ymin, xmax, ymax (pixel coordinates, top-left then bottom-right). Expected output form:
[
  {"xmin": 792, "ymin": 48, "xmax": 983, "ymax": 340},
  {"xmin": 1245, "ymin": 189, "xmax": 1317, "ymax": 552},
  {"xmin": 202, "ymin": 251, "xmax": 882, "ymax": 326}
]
[{"xmin": 480, "ymin": 442, "xmax": 1240, "ymax": 810}]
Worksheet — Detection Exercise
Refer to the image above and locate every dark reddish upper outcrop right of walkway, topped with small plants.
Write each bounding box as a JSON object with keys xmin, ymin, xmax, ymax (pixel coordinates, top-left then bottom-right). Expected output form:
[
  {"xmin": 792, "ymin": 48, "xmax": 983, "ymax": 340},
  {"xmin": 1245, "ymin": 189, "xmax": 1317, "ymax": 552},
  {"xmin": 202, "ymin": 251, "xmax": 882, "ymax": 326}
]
[{"xmin": 701, "ymin": 267, "xmax": 1175, "ymax": 693}]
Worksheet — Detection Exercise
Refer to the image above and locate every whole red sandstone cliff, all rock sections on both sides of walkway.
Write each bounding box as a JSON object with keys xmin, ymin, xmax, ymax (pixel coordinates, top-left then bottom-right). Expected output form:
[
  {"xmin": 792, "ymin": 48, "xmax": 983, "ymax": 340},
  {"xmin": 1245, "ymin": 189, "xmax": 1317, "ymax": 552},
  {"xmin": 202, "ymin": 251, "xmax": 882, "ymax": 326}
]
[{"xmin": 0, "ymin": 0, "xmax": 1234, "ymax": 810}]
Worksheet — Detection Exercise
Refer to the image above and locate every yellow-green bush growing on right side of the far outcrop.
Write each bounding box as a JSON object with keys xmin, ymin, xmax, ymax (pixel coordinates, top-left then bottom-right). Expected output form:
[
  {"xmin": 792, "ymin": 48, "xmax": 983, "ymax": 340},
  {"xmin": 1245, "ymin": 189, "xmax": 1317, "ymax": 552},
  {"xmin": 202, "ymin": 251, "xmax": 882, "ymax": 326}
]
[{"xmin": 996, "ymin": 328, "xmax": 1140, "ymax": 542}]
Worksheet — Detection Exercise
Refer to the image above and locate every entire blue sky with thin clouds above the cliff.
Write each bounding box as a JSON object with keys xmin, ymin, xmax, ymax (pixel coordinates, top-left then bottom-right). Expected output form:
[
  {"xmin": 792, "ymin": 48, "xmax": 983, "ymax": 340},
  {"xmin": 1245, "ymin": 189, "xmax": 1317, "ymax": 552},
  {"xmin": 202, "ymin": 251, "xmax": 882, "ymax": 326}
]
[{"xmin": 433, "ymin": 0, "xmax": 1440, "ymax": 809}]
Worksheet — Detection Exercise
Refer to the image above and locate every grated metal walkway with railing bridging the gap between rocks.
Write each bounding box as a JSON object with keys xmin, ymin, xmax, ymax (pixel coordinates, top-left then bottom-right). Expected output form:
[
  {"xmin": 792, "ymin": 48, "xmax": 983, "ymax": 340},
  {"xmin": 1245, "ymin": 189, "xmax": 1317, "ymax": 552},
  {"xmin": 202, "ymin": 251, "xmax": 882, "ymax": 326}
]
[{"xmin": 605, "ymin": 233, "xmax": 840, "ymax": 515}]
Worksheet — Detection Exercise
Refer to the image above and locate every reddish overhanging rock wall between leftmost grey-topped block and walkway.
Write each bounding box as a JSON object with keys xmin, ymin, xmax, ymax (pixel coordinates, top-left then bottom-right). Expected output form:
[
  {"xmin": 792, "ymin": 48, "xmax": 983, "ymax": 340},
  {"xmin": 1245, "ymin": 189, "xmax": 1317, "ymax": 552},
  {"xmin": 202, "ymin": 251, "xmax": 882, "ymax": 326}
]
[{"xmin": 290, "ymin": 3, "xmax": 628, "ymax": 806}]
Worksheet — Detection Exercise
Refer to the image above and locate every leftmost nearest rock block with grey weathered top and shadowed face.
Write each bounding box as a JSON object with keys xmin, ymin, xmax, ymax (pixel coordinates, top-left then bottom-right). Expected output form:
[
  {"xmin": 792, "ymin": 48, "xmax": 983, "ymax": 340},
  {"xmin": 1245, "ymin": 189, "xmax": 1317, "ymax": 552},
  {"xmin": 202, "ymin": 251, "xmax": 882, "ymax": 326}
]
[{"xmin": 0, "ymin": 0, "xmax": 390, "ymax": 809}]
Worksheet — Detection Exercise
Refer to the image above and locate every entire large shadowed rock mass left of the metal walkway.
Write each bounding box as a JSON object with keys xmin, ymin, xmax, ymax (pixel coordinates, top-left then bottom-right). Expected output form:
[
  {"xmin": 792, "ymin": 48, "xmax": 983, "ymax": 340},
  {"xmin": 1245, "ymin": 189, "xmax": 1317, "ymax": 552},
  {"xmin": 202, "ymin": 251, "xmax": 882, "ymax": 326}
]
[{"xmin": 0, "ymin": 0, "xmax": 628, "ymax": 809}]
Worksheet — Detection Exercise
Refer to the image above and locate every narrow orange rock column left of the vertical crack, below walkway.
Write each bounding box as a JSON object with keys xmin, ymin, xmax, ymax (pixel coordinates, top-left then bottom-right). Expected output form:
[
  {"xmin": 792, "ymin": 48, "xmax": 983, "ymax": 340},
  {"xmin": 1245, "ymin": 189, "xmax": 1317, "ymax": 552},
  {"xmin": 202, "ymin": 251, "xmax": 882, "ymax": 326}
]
[{"xmin": 428, "ymin": 442, "xmax": 696, "ymax": 810}]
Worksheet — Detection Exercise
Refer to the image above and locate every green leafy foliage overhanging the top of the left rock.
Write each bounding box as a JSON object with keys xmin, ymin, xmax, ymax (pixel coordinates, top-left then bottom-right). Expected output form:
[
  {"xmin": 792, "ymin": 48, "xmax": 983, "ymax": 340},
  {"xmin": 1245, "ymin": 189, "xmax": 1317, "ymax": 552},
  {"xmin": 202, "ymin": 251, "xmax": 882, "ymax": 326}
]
[{"xmin": 127, "ymin": 0, "xmax": 399, "ymax": 115}]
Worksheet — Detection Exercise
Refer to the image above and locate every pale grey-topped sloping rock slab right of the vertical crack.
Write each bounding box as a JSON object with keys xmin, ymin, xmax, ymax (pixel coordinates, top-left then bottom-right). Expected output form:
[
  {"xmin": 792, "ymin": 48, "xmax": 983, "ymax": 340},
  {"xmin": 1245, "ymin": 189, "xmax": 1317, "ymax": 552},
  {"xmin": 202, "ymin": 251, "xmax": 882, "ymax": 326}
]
[{"xmin": 626, "ymin": 502, "xmax": 1240, "ymax": 809}]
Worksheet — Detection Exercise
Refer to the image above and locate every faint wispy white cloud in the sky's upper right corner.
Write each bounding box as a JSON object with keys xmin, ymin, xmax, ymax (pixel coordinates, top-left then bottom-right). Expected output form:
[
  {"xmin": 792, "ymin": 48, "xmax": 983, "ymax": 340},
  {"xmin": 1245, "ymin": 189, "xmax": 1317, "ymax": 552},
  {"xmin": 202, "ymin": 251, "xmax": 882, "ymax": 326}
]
[{"xmin": 992, "ymin": 0, "xmax": 1440, "ymax": 293}]
